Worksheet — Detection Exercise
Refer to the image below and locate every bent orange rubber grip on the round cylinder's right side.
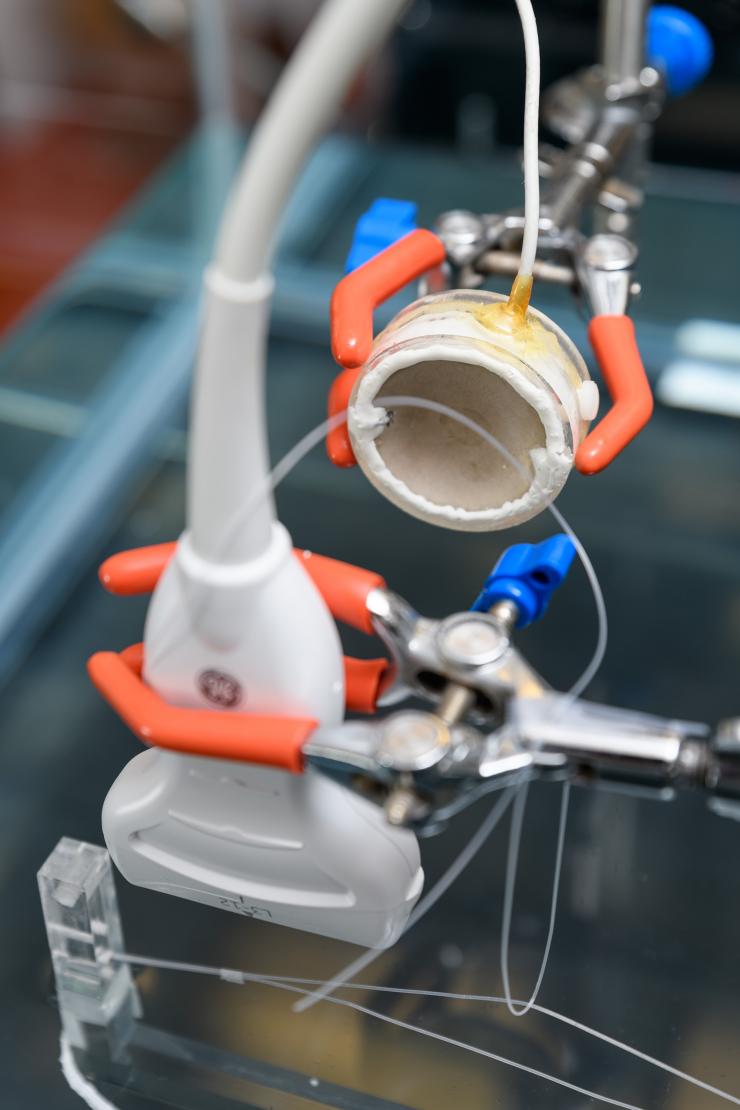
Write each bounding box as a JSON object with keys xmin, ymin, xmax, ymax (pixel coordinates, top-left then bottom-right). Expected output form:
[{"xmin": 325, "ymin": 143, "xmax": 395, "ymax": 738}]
[{"xmin": 576, "ymin": 315, "xmax": 652, "ymax": 474}]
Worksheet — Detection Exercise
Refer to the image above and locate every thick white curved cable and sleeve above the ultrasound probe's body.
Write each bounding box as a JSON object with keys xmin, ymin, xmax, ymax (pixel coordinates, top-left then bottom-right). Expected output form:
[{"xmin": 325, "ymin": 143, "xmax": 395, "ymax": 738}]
[{"xmin": 187, "ymin": 0, "xmax": 406, "ymax": 564}]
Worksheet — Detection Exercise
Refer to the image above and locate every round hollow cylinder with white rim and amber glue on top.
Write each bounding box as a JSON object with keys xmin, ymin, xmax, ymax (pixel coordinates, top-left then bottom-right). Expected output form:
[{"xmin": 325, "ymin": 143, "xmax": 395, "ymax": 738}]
[{"xmin": 348, "ymin": 291, "xmax": 598, "ymax": 532}]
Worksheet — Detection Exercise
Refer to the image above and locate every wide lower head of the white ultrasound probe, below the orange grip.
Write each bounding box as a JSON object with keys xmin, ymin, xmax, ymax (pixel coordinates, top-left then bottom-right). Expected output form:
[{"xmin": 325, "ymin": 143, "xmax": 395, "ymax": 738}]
[{"xmin": 103, "ymin": 749, "xmax": 424, "ymax": 947}]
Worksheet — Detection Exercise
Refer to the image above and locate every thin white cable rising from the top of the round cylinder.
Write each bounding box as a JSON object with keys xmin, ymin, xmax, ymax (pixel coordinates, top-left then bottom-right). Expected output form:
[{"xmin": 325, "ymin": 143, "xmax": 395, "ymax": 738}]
[{"xmin": 516, "ymin": 0, "xmax": 539, "ymax": 276}]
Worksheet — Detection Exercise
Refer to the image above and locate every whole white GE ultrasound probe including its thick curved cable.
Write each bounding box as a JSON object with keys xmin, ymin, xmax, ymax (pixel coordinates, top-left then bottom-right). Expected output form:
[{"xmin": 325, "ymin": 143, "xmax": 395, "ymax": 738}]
[{"xmin": 103, "ymin": 0, "xmax": 423, "ymax": 945}]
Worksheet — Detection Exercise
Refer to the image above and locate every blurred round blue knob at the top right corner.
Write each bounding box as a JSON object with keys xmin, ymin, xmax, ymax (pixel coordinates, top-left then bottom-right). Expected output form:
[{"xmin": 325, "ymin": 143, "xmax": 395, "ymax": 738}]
[{"xmin": 647, "ymin": 4, "xmax": 714, "ymax": 97}]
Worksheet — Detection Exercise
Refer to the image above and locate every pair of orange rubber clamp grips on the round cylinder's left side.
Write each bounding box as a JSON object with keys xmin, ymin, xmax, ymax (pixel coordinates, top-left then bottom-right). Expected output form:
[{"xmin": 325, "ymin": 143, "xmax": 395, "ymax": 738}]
[{"xmin": 326, "ymin": 228, "xmax": 446, "ymax": 466}]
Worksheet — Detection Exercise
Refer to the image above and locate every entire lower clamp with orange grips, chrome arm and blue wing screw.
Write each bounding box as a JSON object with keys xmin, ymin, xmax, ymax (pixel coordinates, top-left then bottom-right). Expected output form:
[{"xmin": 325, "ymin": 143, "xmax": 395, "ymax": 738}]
[{"xmin": 90, "ymin": 536, "xmax": 740, "ymax": 834}]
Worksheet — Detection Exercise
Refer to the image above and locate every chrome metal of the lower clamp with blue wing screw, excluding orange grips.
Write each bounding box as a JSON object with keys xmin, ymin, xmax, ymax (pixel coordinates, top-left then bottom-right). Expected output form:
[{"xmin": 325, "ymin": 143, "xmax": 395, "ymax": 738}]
[{"xmin": 303, "ymin": 537, "xmax": 740, "ymax": 833}]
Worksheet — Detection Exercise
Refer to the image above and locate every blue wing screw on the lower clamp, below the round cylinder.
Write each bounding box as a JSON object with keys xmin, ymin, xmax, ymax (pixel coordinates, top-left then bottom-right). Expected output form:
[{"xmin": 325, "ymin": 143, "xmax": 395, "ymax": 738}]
[{"xmin": 472, "ymin": 533, "xmax": 576, "ymax": 628}]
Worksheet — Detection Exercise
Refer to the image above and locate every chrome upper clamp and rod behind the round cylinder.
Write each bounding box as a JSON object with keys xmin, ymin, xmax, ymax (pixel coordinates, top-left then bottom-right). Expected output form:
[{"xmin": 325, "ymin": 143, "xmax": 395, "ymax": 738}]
[{"xmin": 435, "ymin": 0, "xmax": 665, "ymax": 315}]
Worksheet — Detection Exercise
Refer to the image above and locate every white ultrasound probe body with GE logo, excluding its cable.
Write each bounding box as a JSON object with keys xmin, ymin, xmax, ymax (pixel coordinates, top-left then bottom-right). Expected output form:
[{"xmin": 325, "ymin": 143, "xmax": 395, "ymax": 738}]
[{"xmin": 103, "ymin": 524, "xmax": 424, "ymax": 946}]
